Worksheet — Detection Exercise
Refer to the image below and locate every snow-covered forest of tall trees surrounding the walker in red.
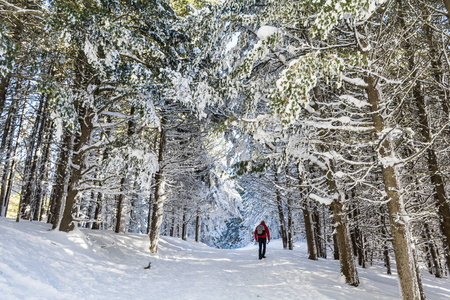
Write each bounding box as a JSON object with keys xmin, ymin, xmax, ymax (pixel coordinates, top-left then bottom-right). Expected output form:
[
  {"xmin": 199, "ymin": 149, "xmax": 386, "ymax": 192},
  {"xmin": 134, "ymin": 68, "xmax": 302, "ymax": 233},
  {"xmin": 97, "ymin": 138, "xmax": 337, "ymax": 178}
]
[{"xmin": 0, "ymin": 0, "xmax": 450, "ymax": 299}]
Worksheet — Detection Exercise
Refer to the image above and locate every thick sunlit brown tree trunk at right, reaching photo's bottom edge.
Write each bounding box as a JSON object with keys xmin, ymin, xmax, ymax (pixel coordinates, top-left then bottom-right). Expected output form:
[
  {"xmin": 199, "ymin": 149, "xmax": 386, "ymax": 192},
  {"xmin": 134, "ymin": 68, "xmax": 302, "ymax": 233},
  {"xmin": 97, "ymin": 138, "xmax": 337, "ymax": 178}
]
[{"xmin": 365, "ymin": 76, "xmax": 424, "ymax": 300}]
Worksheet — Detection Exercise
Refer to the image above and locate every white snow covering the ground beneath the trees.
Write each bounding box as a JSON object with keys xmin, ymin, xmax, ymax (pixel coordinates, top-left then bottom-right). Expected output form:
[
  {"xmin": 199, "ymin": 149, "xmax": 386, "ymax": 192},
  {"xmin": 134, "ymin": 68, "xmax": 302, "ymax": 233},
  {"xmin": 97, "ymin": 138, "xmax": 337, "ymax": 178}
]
[{"xmin": 0, "ymin": 218, "xmax": 450, "ymax": 300}]
